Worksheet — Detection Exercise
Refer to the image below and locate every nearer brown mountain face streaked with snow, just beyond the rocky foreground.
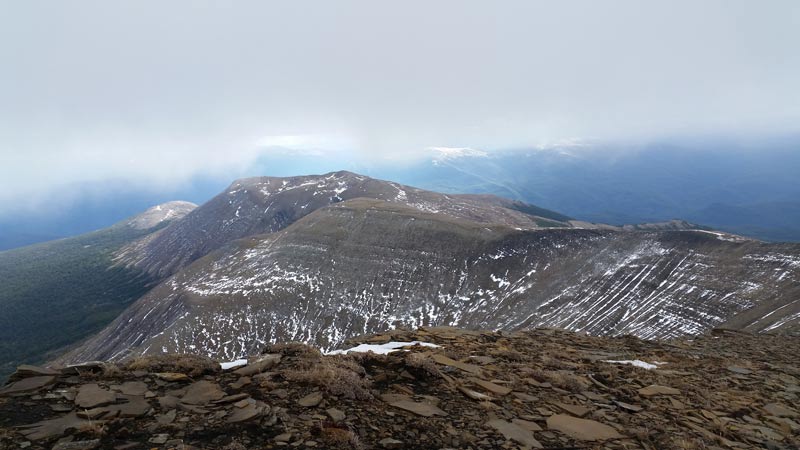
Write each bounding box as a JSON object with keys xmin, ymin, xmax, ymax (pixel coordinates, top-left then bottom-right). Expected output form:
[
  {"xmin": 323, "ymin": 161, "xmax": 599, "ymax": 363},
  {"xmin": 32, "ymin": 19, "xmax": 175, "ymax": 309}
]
[{"xmin": 64, "ymin": 192, "xmax": 800, "ymax": 361}]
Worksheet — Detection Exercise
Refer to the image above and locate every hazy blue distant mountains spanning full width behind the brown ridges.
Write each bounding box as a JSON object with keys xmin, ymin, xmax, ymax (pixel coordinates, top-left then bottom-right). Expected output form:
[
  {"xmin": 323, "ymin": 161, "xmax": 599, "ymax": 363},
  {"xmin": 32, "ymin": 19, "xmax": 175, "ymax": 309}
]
[{"xmin": 0, "ymin": 136, "xmax": 800, "ymax": 250}]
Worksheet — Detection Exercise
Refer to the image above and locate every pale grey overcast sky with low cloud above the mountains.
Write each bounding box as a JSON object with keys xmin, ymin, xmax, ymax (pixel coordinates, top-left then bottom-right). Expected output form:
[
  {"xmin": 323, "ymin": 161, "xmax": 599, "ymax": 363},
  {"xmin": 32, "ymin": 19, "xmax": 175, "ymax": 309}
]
[{"xmin": 0, "ymin": 0, "xmax": 800, "ymax": 206}]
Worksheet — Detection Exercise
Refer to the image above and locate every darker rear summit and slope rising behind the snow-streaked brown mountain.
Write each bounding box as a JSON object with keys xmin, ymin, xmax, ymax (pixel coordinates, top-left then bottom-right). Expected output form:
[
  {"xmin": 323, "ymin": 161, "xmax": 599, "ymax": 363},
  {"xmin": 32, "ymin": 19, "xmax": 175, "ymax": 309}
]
[{"xmin": 118, "ymin": 172, "xmax": 571, "ymax": 277}]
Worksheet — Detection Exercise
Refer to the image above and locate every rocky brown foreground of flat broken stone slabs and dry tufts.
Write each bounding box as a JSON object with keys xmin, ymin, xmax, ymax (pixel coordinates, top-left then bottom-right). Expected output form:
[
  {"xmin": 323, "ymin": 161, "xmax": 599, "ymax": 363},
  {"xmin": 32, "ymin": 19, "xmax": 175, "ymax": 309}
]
[{"xmin": 0, "ymin": 328, "xmax": 800, "ymax": 450}]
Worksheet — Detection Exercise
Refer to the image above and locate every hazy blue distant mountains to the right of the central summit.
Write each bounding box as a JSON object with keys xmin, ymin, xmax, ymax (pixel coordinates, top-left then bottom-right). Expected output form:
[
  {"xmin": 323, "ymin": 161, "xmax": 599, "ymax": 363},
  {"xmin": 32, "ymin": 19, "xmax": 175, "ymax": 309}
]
[{"xmin": 381, "ymin": 139, "xmax": 800, "ymax": 241}]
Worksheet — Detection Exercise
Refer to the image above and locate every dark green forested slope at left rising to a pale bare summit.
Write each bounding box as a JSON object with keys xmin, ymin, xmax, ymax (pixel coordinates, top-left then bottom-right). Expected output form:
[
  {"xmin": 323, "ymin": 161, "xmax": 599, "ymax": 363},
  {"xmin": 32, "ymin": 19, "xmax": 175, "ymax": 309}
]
[{"xmin": 0, "ymin": 202, "xmax": 195, "ymax": 377}]
